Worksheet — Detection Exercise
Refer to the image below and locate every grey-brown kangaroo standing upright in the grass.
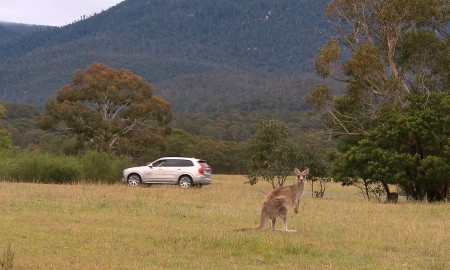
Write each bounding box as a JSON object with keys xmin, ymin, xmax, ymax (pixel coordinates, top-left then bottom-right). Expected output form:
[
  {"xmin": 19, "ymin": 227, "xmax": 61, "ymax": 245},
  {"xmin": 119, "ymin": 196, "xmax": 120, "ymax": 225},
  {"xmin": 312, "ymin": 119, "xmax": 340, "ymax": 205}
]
[{"xmin": 236, "ymin": 168, "xmax": 309, "ymax": 232}]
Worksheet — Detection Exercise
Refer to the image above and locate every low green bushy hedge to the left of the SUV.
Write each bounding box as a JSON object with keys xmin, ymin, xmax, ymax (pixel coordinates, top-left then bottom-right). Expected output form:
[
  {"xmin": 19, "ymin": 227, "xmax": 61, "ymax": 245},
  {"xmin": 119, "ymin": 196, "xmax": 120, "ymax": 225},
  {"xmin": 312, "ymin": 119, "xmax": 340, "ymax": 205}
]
[{"xmin": 0, "ymin": 151, "xmax": 132, "ymax": 184}]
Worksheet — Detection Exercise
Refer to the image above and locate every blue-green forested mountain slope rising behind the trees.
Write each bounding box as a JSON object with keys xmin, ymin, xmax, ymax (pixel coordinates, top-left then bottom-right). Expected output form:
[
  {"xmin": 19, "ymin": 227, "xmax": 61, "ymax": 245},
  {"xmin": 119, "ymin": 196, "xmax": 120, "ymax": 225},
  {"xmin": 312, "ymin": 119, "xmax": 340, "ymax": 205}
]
[{"xmin": 0, "ymin": 0, "xmax": 327, "ymax": 111}]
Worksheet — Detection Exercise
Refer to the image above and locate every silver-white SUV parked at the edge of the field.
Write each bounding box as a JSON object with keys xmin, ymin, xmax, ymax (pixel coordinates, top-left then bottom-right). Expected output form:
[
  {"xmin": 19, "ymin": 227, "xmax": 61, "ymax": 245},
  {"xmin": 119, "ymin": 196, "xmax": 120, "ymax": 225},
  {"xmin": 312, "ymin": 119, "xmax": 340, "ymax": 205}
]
[{"xmin": 122, "ymin": 157, "xmax": 211, "ymax": 188}]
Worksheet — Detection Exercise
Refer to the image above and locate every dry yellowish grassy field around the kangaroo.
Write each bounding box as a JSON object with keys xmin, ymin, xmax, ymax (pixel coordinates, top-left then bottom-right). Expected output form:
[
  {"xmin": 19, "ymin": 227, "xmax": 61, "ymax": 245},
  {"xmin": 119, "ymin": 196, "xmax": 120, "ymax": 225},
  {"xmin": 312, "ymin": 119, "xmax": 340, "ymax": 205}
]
[{"xmin": 0, "ymin": 175, "xmax": 450, "ymax": 269}]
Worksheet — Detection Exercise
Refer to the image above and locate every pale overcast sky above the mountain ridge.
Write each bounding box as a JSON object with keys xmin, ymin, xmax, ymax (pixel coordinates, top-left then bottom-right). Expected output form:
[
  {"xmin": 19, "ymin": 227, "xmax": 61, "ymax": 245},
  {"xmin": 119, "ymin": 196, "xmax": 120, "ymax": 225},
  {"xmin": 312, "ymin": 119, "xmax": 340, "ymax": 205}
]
[{"xmin": 0, "ymin": 0, "xmax": 123, "ymax": 26}]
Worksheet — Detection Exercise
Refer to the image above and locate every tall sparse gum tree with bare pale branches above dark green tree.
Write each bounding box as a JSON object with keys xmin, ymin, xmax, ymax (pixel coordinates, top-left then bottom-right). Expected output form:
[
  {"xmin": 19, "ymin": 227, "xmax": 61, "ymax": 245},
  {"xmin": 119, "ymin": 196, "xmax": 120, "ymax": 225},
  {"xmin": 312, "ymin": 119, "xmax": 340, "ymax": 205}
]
[{"xmin": 308, "ymin": 0, "xmax": 450, "ymax": 136}]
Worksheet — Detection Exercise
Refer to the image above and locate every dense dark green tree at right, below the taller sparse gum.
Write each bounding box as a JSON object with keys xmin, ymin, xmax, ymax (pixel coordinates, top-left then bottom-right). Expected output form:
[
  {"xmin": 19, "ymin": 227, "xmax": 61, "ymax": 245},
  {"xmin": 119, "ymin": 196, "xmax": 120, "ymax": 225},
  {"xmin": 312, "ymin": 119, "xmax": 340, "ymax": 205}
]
[{"xmin": 334, "ymin": 93, "xmax": 450, "ymax": 201}]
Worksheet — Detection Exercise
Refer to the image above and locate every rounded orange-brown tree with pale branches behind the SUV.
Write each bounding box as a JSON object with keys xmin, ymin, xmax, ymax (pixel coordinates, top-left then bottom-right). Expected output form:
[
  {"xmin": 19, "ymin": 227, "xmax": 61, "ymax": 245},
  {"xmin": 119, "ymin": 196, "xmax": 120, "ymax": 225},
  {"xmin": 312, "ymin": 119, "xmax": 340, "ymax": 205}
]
[{"xmin": 42, "ymin": 62, "xmax": 172, "ymax": 157}]
